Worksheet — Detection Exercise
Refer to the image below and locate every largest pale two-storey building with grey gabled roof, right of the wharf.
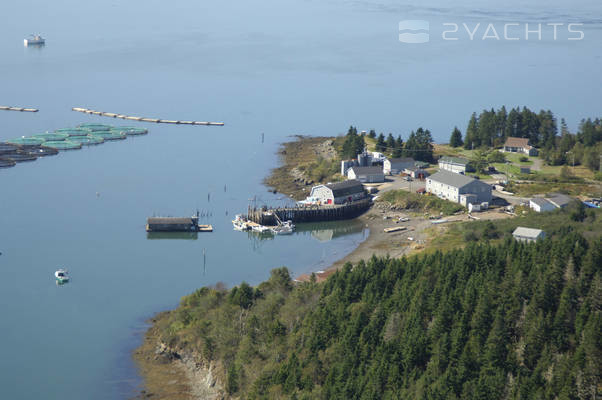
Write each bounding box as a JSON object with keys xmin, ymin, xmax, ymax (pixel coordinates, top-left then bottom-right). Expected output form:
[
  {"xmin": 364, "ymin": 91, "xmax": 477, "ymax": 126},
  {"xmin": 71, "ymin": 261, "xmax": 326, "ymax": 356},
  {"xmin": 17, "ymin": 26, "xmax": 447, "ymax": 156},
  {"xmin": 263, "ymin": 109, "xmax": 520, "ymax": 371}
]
[{"xmin": 426, "ymin": 171, "xmax": 491, "ymax": 207}]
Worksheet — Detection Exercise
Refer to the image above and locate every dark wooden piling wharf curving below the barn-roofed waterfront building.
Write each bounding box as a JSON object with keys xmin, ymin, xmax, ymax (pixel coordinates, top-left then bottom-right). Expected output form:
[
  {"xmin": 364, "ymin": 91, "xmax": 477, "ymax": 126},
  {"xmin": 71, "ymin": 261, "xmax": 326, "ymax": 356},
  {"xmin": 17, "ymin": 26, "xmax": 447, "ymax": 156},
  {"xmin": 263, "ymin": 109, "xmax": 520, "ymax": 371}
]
[{"xmin": 247, "ymin": 198, "xmax": 372, "ymax": 226}]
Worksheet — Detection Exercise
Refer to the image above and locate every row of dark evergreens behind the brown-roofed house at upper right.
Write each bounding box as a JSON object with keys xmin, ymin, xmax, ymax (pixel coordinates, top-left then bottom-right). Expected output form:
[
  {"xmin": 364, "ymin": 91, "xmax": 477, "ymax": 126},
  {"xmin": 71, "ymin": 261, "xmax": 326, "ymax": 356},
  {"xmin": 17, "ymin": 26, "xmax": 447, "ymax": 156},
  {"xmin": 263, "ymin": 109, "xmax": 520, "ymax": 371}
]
[{"xmin": 450, "ymin": 106, "xmax": 602, "ymax": 171}]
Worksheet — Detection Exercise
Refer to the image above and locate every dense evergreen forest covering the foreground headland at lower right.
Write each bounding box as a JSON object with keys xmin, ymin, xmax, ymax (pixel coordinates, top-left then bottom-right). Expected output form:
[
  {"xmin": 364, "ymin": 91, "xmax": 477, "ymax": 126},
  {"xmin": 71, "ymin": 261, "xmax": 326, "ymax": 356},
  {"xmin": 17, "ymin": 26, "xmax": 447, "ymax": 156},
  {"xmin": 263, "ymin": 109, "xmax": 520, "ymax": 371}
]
[{"xmin": 157, "ymin": 220, "xmax": 602, "ymax": 400}]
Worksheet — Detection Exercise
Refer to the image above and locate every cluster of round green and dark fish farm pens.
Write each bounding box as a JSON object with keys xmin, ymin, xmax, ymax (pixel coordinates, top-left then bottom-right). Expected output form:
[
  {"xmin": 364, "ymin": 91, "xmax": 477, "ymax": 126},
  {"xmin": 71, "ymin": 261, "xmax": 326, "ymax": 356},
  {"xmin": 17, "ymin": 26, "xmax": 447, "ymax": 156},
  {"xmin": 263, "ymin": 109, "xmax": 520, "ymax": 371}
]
[{"xmin": 0, "ymin": 124, "xmax": 148, "ymax": 168}]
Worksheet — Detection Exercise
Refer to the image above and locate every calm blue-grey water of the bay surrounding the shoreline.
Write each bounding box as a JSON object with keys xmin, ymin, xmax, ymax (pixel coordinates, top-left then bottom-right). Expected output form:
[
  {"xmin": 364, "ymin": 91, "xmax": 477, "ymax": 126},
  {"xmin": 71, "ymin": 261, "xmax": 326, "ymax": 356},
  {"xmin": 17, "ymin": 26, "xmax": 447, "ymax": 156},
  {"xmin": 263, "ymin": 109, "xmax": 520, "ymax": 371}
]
[{"xmin": 0, "ymin": 0, "xmax": 602, "ymax": 399}]
